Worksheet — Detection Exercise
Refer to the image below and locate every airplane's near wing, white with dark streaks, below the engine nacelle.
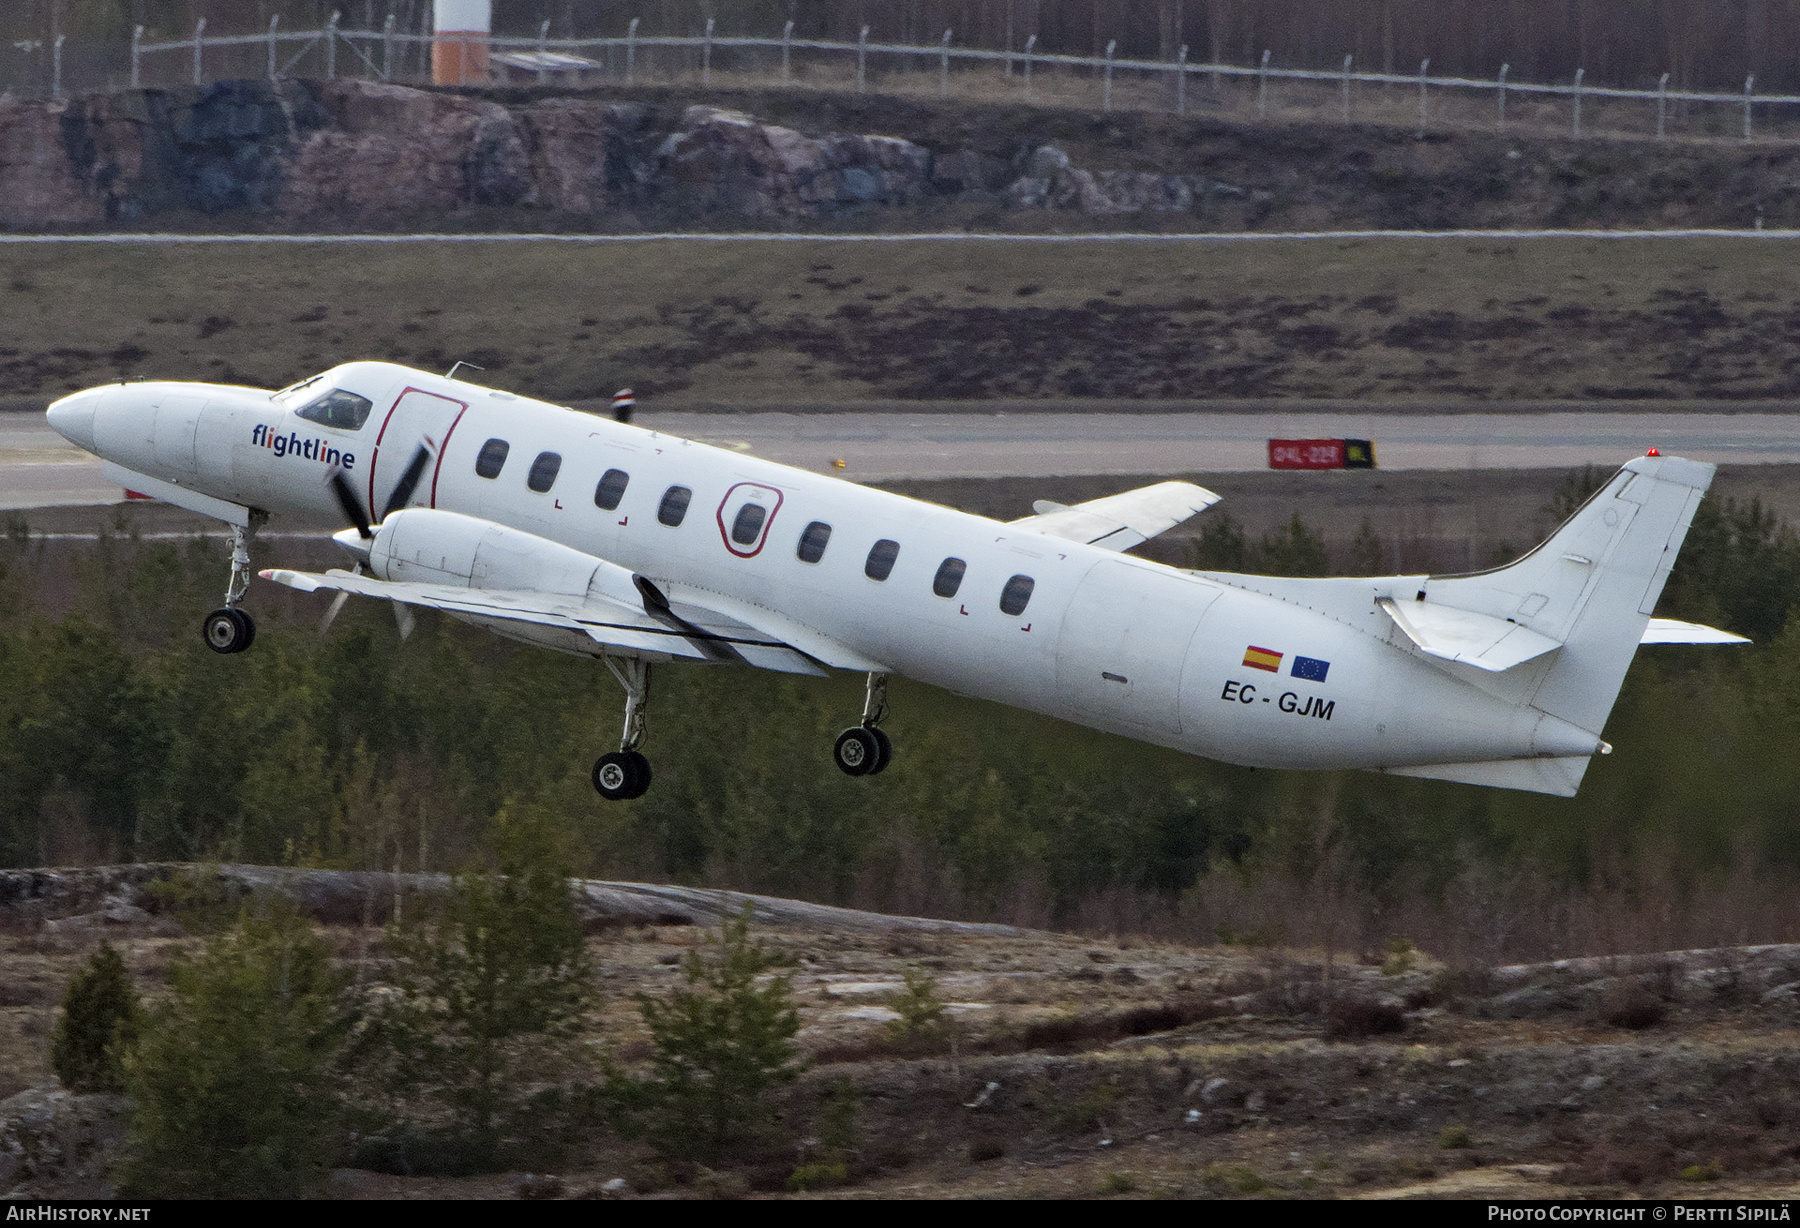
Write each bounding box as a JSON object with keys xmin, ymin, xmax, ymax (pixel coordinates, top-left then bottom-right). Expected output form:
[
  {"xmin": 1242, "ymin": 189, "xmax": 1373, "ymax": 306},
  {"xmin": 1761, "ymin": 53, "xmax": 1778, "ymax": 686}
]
[{"xmin": 261, "ymin": 567, "xmax": 824, "ymax": 675}]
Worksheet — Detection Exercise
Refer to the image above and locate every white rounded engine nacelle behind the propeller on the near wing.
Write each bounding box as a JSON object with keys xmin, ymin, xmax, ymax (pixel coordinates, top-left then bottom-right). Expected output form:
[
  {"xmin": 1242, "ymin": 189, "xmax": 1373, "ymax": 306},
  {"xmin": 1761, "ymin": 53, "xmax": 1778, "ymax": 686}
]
[{"xmin": 369, "ymin": 508, "xmax": 643, "ymax": 605}]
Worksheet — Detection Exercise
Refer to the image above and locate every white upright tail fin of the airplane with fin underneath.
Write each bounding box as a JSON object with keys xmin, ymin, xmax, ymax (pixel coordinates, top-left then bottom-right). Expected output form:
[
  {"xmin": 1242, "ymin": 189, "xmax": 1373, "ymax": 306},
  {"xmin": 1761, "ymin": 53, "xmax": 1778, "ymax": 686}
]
[{"xmin": 1400, "ymin": 456, "xmax": 1714, "ymax": 796}]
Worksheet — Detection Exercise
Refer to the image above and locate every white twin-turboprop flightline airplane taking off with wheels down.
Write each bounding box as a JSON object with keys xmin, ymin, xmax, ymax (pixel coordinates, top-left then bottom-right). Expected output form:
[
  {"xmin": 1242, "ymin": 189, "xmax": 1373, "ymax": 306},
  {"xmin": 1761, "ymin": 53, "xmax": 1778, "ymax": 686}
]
[{"xmin": 49, "ymin": 362, "xmax": 1744, "ymax": 798}]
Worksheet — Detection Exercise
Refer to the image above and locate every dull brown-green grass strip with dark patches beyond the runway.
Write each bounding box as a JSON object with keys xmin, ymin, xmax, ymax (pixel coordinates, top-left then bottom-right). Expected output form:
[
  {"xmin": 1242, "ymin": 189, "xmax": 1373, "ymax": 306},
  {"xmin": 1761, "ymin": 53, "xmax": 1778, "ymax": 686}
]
[{"xmin": 10, "ymin": 239, "xmax": 1800, "ymax": 407}]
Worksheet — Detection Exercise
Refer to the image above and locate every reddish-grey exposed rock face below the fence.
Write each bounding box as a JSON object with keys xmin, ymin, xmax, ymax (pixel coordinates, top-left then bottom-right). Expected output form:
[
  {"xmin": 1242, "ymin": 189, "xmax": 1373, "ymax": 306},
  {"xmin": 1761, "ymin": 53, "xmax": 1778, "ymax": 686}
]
[{"xmin": 0, "ymin": 81, "xmax": 1237, "ymax": 229}]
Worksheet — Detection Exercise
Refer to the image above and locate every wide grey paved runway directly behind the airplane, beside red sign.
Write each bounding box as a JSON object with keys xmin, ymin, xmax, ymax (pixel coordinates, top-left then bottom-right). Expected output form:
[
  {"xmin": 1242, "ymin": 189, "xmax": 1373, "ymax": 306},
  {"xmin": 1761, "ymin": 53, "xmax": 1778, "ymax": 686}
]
[{"xmin": 0, "ymin": 411, "xmax": 1800, "ymax": 510}]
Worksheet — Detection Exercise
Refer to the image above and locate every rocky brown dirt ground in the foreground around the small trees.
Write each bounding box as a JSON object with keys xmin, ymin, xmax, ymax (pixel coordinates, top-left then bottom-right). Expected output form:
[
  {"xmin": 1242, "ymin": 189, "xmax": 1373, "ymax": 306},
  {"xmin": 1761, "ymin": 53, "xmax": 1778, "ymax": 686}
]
[{"xmin": 10, "ymin": 878, "xmax": 1800, "ymax": 1199}]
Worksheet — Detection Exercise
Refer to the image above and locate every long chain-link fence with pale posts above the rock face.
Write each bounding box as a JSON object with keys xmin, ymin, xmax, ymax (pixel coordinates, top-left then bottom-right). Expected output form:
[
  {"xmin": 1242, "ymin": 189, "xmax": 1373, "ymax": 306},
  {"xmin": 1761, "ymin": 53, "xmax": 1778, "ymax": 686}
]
[{"xmin": 0, "ymin": 18, "xmax": 1800, "ymax": 140}]
